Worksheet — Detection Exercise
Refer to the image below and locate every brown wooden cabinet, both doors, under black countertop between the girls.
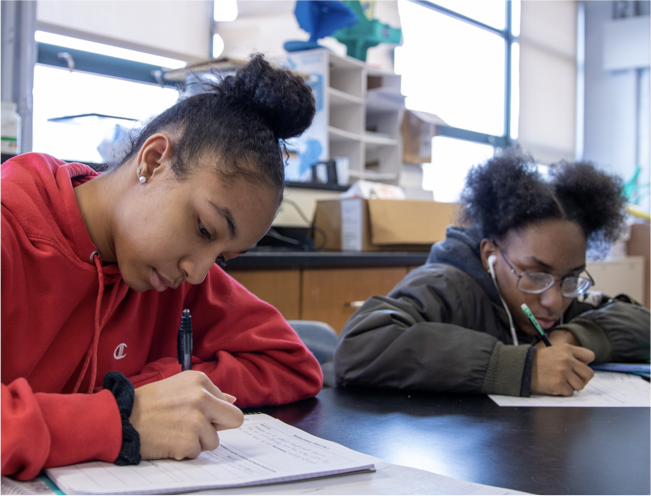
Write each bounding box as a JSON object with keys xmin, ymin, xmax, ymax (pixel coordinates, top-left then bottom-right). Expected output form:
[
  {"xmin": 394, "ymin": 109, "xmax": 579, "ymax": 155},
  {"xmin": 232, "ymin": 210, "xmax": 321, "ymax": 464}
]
[{"xmin": 229, "ymin": 267, "xmax": 408, "ymax": 333}]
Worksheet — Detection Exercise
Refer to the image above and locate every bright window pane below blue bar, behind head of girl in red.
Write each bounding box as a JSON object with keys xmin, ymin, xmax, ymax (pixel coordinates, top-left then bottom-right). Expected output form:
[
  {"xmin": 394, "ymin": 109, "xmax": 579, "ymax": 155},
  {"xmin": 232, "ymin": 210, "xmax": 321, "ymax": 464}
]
[{"xmin": 33, "ymin": 64, "xmax": 178, "ymax": 163}]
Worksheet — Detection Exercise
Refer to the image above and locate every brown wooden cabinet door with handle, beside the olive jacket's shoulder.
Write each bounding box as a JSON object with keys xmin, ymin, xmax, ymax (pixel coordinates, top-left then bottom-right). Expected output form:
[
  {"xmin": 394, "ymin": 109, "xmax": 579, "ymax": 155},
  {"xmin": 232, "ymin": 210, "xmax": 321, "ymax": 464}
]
[{"xmin": 301, "ymin": 267, "xmax": 407, "ymax": 333}]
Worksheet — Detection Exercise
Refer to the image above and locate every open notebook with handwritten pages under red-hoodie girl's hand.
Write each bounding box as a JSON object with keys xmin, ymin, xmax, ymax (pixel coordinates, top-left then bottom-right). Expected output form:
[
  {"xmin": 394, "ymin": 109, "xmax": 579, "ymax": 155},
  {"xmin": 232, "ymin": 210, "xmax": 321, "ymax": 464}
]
[{"xmin": 46, "ymin": 414, "xmax": 380, "ymax": 496}]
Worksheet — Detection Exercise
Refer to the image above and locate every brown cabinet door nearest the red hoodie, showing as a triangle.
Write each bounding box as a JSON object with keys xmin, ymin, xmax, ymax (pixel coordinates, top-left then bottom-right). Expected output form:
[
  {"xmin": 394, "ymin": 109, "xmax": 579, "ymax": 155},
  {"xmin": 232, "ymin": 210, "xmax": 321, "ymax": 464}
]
[{"xmin": 228, "ymin": 269, "xmax": 301, "ymax": 320}]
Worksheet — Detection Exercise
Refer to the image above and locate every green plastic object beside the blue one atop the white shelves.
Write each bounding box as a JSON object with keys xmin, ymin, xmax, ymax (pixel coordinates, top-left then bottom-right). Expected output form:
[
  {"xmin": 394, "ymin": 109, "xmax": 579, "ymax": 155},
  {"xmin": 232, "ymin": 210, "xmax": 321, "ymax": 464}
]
[{"xmin": 332, "ymin": 0, "xmax": 402, "ymax": 62}]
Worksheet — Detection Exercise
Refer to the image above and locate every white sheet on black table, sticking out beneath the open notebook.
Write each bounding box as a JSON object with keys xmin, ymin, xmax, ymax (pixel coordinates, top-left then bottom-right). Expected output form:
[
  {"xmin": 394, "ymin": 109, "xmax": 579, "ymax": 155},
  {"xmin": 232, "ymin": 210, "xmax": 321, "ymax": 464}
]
[{"xmin": 195, "ymin": 462, "xmax": 532, "ymax": 496}]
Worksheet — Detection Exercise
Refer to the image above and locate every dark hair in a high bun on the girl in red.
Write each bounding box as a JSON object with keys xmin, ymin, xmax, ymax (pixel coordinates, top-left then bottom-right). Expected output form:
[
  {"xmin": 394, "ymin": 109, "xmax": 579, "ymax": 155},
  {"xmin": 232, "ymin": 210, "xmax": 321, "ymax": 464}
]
[{"xmin": 117, "ymin": 54, "xmax": 316, "ymax": 200}]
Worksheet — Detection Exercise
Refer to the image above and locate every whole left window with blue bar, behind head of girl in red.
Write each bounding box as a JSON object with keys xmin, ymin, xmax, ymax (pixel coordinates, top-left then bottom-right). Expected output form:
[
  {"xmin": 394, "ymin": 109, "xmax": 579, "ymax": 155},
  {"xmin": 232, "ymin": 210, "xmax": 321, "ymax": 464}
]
[{"xmin": 32, "ymin": 31, "xmax": 185, "ymax": 164}]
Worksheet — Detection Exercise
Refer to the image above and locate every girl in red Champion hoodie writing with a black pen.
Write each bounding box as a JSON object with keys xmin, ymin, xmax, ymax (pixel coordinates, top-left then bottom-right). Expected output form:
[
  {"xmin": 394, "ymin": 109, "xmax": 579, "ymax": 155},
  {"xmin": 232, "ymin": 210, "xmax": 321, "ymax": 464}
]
[{"xmin": 0, "ymin": 56, "xmax": 322, "ymax": 479}]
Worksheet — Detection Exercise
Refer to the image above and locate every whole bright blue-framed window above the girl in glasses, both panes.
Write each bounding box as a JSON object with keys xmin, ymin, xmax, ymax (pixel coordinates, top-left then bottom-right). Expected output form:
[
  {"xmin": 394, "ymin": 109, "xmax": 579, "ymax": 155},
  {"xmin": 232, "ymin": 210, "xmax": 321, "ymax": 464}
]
[{"xmin": 395, "ymin": 0, "xmax": 520, "ymax": 201}]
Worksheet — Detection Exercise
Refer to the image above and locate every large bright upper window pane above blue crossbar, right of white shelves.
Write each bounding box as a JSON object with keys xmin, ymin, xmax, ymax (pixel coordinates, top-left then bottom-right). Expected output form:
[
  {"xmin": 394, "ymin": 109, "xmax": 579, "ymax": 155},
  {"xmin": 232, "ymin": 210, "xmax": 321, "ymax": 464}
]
[{"xmin": 396, "ymin": 0, "xmax": 505, "ymax": 136}]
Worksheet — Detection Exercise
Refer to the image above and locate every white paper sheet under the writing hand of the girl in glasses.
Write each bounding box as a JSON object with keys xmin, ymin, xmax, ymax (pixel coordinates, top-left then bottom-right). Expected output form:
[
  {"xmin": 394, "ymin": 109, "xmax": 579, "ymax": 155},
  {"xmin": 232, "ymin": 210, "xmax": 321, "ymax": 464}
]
[{"xmin": 488, "ymin": 370, "xmax": 651, "ymax": 407}]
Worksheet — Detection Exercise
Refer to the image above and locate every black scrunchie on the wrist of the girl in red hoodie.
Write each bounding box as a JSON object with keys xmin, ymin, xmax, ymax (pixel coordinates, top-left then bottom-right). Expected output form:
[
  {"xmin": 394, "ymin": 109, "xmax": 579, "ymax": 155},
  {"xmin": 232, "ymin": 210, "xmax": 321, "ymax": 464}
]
[{"xmin": 102, "ymin": 371, "xmax": 140, "ymax": 465}]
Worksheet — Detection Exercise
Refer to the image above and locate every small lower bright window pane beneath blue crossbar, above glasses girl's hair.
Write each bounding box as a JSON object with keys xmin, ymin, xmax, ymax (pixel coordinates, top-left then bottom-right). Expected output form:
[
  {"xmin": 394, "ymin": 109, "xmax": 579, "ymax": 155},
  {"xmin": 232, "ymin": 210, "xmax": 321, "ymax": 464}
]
[{"xmin": 423, "ymin": 136, "xmax": 494, "ymax": 202}]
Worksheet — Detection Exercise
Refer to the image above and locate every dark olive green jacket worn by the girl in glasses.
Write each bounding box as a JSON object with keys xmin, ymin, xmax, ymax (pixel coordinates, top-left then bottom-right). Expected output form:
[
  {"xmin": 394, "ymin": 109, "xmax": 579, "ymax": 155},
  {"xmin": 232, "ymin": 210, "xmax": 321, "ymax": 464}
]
[{"xmin": 334, "ymin": 228, "xmax": 651, "ymax": 396}]
